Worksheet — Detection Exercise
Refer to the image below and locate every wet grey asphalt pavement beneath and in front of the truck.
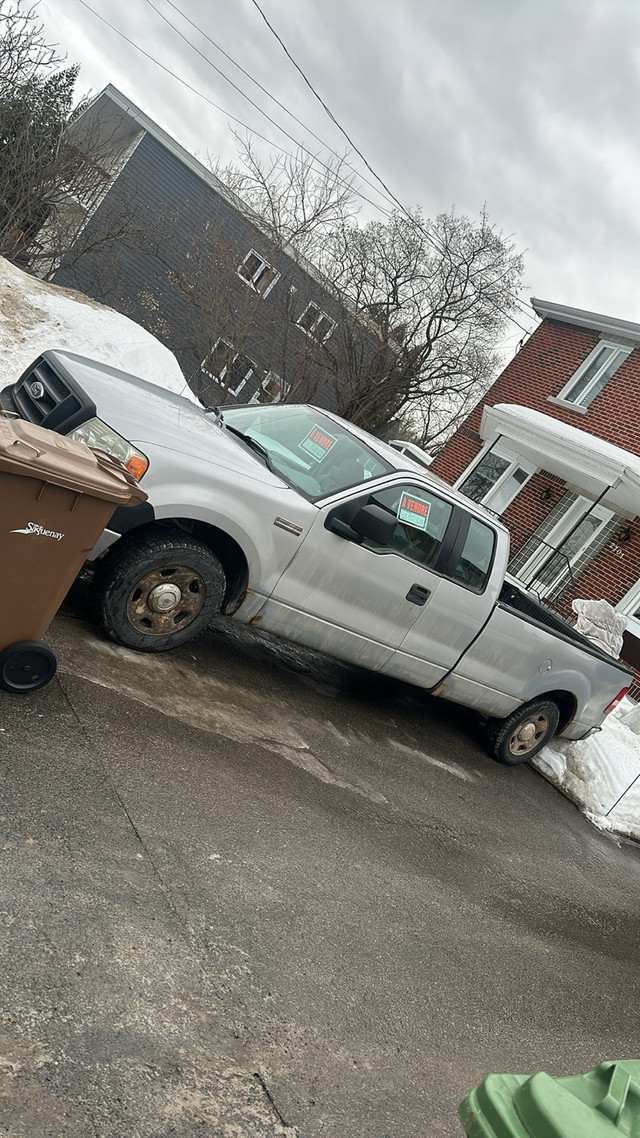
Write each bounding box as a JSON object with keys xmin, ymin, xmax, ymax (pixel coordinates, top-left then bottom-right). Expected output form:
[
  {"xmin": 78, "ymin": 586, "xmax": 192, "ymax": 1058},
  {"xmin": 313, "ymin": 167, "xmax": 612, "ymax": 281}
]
[{"xmin": 0, "ymin": 593, "xmax": 640, "ymax": 1138}]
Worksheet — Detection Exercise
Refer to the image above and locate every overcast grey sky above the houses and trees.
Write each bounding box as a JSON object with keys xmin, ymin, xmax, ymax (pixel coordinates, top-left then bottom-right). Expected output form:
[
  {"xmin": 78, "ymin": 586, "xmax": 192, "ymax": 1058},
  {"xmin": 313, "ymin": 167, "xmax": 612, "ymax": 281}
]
[{"xmin": 40, "ymin": 0, "xmax": 640, "ymax": 343}]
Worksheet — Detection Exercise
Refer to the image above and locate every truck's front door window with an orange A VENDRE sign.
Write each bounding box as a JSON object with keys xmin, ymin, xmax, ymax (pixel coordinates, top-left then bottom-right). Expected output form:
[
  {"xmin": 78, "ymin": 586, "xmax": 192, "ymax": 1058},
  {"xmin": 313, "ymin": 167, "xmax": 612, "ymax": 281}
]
[{"xmin": 362, "ymin": 485, "xmax": 452, "ymax": 568}]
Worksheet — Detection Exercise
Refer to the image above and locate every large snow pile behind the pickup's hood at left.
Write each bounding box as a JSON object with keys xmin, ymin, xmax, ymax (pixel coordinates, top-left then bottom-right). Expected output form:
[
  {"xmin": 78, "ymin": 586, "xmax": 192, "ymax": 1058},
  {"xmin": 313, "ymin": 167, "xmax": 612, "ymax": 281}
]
[{"xmin": 0, "ymin": 257, "xmax": 199, "ymax": 405}]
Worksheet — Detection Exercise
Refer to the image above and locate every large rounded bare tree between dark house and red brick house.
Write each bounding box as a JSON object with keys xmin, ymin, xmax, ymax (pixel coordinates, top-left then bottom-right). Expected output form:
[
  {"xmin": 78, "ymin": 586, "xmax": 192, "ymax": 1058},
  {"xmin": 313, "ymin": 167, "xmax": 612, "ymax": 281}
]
[{"xmin": 319, "ymin": 204, "xmax": 523, "ymax": 445}]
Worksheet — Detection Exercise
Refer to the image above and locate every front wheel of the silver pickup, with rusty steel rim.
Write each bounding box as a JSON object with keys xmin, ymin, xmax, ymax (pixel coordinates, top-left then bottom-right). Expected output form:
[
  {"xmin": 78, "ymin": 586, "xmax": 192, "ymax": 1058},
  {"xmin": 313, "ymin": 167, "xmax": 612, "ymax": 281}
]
[{"xmin": 95, "ymin": 533, "xmax": 225, "ymax": 652}]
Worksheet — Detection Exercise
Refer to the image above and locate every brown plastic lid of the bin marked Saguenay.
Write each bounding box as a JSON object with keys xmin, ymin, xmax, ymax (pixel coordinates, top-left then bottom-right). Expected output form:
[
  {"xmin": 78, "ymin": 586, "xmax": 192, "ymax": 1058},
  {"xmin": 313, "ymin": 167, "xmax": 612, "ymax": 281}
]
[{"xmin": 0, "ymin": 415, "xmax": 147, "ymax": 505}]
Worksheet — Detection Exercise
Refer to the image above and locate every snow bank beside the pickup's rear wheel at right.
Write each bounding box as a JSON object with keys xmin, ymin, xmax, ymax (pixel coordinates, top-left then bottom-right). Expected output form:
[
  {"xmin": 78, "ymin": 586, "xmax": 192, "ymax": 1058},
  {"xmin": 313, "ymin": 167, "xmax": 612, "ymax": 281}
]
[{"xmin": 532, "ymin": 699, "xmax": 640, "ymax": 841}]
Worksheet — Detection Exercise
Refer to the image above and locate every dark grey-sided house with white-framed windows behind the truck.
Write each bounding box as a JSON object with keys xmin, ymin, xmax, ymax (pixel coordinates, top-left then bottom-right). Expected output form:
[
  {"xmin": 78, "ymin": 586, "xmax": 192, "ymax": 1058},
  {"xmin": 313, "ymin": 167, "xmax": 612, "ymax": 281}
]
[{"xmin": 44, "ymin": 85, "xmax": 388, "ymax": 406}]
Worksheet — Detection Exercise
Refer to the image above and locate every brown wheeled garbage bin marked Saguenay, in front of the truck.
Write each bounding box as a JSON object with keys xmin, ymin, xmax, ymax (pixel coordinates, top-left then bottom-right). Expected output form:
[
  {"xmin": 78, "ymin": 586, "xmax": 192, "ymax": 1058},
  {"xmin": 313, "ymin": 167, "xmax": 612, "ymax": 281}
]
[{"xmin": 0, "ymin": 414, "xmax": 147, "ymax": 692}]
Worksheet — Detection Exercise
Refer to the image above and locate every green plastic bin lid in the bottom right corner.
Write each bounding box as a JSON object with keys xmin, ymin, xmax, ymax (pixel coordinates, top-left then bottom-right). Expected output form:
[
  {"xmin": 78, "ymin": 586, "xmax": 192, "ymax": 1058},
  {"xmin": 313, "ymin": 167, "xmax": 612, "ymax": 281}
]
[{"xmin": 458, "ymin": 1059, "xmax": 640, "ymax": 1138}]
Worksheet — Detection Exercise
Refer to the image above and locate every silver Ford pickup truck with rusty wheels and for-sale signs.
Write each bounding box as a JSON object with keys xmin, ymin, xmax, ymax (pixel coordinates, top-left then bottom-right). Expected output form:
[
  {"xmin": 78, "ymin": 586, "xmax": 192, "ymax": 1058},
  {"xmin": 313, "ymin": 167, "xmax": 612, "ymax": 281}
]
[{"xmin": 0, "ymin": 352, "xmax": 630, "ymax": 764}]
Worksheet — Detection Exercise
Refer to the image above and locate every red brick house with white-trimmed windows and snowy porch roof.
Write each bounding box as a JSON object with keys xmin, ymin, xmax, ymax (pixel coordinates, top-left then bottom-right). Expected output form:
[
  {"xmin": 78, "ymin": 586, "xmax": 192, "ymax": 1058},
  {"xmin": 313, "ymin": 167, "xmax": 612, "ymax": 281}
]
[{"xmin": 432, "ymin": 299, "xmax": 640, "ymax": 694}]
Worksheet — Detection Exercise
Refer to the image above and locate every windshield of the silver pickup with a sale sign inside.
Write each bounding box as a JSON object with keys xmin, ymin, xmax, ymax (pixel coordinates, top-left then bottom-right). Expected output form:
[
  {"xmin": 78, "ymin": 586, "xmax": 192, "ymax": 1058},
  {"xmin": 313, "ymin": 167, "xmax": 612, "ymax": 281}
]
[{"xmin": 220, "ymin": 403, "xmax": 394, "ymax": 498}]
